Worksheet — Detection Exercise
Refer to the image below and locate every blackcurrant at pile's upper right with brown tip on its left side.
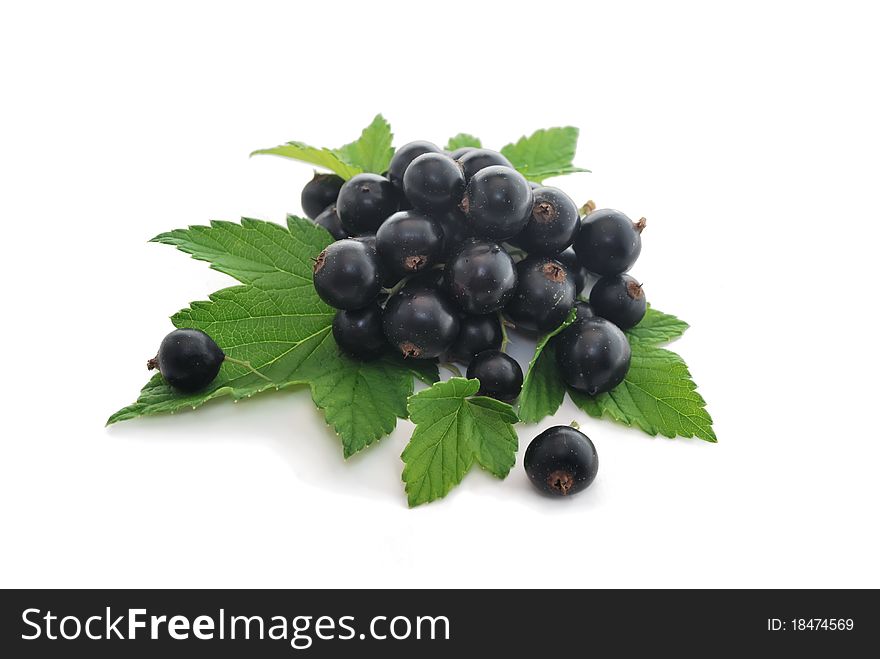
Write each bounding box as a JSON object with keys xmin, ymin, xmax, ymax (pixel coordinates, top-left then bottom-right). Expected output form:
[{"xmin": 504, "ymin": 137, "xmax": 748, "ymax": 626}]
[{"xmin": 517, "ymin": 188, "xmax": 581, "ymax": 256}]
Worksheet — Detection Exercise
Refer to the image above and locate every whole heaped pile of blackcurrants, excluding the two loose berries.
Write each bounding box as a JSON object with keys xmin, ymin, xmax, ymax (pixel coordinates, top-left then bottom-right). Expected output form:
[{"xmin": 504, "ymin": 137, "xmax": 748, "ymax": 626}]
[{"xmin": 302, "ymin": 142, "xmax": 646, "ymax": 402}]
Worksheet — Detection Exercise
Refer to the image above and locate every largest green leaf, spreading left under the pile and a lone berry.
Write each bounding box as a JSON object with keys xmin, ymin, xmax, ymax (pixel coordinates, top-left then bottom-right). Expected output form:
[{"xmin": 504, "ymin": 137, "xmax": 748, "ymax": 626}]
[{"xmin": 108, "ymin": 216, "xmax": 438, "ymax": 457}]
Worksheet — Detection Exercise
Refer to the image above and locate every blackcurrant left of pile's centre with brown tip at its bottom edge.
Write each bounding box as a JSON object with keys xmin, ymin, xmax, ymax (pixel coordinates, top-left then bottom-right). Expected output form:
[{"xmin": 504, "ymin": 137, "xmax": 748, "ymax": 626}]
[{"xmin": 376, "ymin": 211, "xmax": 443, "ymax": 278}]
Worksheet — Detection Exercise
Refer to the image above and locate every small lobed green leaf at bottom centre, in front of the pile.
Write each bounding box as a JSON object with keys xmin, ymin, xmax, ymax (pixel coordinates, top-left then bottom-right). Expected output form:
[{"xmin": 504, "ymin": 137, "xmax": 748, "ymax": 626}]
[{"xmin": 401, "ymin": 378, "xmax": 517, "ymax": 506}]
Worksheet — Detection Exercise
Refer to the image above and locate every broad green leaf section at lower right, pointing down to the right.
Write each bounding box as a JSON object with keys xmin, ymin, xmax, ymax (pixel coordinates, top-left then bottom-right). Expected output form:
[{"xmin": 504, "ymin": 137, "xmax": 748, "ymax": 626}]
[{"xmin": 569, "ymin": 343, "xmax": 718, "ymax": 442}]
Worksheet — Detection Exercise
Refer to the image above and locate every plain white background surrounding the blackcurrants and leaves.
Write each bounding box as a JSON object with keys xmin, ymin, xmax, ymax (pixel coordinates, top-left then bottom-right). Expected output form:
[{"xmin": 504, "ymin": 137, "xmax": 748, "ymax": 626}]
[{"xmin": 0, "ymin": 0, "xmax": 880, "ymax": 588}]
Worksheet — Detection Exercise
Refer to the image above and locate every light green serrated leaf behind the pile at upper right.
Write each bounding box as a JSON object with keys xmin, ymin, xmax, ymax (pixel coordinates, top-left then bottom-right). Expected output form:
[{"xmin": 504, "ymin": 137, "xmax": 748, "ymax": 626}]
[{"xmin": 501, "ymin": 126, "xmax": 590, "ymax": 183}]
